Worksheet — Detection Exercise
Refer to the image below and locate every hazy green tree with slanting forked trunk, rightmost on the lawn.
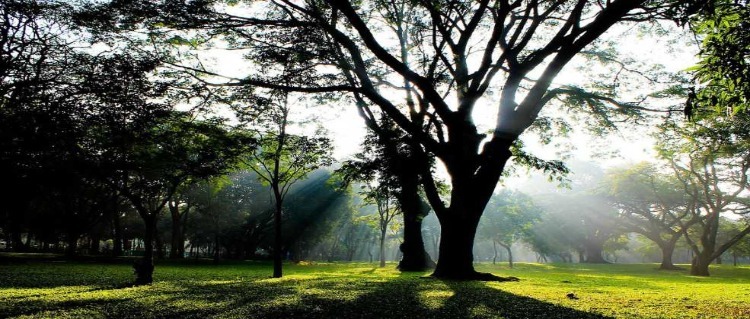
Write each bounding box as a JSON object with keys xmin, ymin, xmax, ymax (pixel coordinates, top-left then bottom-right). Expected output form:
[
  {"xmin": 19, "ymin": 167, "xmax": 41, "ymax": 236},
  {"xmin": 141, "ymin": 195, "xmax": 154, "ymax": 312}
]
[{"xmin": 657, "ymin": 112, "xmax": 750, "ymax": 276}]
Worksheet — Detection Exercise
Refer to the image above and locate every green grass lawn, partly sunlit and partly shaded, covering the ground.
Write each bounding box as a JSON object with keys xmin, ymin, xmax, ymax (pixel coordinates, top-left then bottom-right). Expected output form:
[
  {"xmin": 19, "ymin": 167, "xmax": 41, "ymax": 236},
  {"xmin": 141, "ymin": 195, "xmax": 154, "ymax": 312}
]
[{"xmin": 0, "ymin": 260, "xmax": 750, "ymax": 318}]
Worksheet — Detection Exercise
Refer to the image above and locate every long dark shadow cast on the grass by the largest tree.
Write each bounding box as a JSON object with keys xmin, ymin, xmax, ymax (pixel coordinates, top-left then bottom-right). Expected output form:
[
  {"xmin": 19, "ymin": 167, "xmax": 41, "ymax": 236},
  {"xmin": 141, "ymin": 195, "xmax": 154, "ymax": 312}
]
[{"xmin": 214, "ymin": 275, "xmax": 608, "ymax": 318}]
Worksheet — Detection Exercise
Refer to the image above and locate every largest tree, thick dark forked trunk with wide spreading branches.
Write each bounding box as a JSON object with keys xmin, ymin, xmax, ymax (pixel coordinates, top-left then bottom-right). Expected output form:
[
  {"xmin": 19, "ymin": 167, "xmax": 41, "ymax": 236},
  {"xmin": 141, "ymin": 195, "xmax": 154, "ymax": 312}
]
[{"xmin": 86, "ymin": 0, "xmax": 700, "ymax": 279}]
